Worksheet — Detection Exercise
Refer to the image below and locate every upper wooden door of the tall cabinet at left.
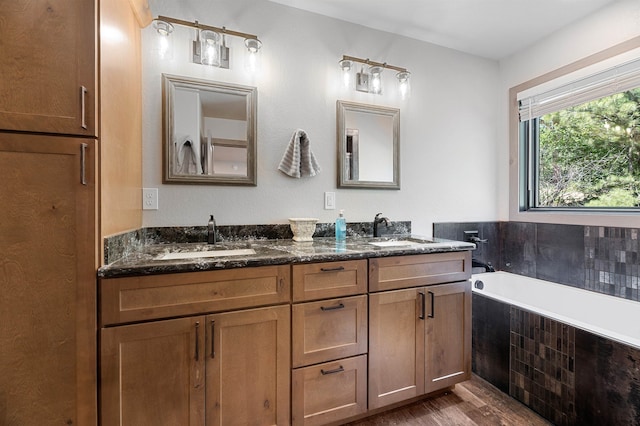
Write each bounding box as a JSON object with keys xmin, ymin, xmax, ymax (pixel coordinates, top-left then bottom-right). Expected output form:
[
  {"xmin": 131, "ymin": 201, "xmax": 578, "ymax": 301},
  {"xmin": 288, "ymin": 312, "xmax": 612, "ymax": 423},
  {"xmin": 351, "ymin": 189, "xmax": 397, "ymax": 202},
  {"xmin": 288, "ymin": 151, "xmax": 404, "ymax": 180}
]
[{"xmin": 0, "ymin": 0, "xmax": 97, "ymax": 136}]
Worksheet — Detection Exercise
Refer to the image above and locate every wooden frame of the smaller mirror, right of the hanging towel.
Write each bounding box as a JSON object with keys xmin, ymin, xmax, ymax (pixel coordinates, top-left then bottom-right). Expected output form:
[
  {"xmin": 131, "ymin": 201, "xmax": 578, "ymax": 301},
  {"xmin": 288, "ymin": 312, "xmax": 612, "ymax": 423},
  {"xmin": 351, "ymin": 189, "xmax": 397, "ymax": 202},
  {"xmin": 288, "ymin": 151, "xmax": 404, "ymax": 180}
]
[{"xmin": 336, "ymin": 100, "xmax": 400, "ymax": 189}]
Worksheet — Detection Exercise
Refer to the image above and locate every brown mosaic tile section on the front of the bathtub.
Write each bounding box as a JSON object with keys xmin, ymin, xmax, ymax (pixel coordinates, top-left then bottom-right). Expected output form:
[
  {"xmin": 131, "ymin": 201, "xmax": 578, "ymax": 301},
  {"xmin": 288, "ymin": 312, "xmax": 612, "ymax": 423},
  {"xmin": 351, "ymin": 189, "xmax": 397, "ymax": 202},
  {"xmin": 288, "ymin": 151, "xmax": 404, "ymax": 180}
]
[{"xmin": 509, "ymin": 306, "xmax": 576, "ymax": 425}]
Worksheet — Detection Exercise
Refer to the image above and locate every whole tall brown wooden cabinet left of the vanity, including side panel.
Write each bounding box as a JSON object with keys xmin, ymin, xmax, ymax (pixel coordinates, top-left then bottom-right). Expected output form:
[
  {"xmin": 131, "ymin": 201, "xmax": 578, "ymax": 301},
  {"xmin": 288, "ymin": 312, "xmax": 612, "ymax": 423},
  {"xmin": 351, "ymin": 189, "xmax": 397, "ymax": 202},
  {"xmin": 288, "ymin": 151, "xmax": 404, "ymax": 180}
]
[{"xmin": 0, "ymin": 0, "xmax": 142, "ymax": 426}]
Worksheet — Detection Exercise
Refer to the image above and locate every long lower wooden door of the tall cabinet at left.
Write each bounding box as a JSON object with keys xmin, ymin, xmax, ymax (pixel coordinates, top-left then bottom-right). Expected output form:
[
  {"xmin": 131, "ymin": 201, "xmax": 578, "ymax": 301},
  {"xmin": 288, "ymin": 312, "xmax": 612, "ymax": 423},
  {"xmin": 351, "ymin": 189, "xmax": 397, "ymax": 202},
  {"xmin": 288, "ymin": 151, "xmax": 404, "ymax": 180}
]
[{"xmin": 0, "ymin": 133, "xmax": 97, "ymax": 426}]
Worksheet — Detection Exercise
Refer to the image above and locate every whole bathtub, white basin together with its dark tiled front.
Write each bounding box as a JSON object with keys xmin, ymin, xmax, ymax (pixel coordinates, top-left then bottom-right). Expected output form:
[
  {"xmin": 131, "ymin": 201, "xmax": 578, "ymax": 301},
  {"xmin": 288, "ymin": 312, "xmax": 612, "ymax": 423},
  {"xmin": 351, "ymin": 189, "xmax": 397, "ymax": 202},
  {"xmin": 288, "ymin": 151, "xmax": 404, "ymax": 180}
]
[{"xmin": 471, "ymin": 272, "xmax": 640, "ymax": 426}]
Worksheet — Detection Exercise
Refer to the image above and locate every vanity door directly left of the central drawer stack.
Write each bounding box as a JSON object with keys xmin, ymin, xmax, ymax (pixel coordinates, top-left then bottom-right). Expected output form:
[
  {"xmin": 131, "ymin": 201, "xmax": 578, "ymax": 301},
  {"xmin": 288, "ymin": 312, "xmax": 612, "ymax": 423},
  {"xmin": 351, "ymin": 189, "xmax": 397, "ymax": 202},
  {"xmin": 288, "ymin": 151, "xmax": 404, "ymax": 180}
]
[{"xmin": 206, "ymin": 305, "xmax": 291, "ymax": 426}]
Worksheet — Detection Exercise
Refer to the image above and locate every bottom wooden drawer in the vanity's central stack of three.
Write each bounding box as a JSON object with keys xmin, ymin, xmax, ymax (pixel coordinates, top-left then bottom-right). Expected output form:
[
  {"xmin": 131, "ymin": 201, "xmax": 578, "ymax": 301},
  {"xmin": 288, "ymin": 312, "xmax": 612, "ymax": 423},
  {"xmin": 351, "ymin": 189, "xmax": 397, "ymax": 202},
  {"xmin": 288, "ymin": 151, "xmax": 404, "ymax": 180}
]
[{"xmin": 292, "ymin": 355, "xmax": 367, "ymax": 425}]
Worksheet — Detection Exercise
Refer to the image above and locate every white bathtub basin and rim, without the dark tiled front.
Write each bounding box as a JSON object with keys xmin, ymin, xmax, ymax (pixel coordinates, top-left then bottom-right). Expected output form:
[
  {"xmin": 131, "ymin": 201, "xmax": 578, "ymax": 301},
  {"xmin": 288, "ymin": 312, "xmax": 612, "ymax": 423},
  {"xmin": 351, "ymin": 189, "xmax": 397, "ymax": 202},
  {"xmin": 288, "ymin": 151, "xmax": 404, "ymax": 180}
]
[{"xmin": 471, "ymin": 272, "xmax": 640, "ymax": 349}]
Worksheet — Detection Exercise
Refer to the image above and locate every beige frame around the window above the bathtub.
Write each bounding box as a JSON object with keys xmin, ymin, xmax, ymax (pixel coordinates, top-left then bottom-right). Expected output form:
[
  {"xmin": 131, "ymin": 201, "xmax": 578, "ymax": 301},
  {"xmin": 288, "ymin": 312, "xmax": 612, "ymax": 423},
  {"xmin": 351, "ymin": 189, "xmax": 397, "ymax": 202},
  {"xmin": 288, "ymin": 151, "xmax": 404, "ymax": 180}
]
[{"xmin": 508, "ymin": 37, "xmax": 640, "ymax": 227}]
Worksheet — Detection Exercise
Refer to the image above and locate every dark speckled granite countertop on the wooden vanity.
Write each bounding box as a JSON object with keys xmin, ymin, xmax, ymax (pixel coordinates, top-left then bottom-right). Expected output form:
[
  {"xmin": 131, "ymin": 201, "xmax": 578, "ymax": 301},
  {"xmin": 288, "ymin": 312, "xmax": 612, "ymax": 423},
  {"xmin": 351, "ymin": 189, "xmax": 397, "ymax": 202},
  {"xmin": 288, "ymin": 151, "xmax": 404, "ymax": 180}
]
[{"xmin": 98, "ymin": 235, "xmax": 475, "ymax": 278}]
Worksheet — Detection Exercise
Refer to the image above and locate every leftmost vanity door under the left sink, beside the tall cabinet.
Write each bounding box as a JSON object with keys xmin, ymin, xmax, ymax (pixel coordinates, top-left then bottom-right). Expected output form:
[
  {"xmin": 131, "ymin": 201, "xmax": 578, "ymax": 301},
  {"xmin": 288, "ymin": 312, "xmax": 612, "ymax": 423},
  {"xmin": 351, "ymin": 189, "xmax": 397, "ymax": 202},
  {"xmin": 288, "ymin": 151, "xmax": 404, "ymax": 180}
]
[{"xmin": 101, "ymin": 317, "xmax": 205, "ymax": 426}]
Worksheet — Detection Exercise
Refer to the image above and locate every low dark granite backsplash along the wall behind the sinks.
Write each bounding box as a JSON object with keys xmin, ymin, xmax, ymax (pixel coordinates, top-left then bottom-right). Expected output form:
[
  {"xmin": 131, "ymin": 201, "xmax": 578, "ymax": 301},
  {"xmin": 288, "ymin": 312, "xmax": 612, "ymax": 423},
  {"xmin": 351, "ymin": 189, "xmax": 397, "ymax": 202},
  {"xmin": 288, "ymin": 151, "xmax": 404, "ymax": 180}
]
[{"xmin": 104, "ymin": 221, "xmax": 411, "ymax": 265}]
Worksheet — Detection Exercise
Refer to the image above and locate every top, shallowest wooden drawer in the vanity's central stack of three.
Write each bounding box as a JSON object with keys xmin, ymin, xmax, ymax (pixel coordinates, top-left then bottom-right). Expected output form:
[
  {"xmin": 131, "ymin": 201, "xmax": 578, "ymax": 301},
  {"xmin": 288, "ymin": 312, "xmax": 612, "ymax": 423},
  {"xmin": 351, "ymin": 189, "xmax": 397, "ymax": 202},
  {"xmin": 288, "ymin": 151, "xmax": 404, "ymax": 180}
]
[{"xmin": 292, "ymin": 259, "xmax": 367, "ymax": 302}]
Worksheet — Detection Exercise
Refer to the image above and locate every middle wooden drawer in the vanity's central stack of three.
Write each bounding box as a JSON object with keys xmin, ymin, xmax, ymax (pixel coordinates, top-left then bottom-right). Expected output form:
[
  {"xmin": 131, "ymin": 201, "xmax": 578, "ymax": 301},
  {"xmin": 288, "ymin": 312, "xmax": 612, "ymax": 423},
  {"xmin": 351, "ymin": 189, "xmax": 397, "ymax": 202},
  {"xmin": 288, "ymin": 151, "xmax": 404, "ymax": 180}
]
[{"xmin": 292, "ymin": 294, "xmax": 368, "ymax": 367}]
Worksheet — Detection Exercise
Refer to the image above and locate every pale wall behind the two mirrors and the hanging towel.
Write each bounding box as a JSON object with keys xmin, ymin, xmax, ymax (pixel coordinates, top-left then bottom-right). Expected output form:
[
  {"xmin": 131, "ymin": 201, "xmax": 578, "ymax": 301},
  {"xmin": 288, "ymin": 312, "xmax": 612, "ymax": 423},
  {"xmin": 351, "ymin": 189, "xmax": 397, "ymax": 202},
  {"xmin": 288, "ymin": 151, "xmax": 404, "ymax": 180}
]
[{"xmin": 142, "ymin": 0, "xmax": 499, "ymax": 236}]
